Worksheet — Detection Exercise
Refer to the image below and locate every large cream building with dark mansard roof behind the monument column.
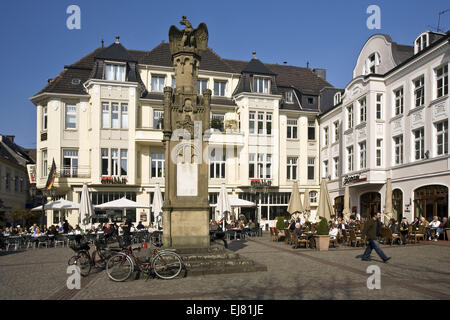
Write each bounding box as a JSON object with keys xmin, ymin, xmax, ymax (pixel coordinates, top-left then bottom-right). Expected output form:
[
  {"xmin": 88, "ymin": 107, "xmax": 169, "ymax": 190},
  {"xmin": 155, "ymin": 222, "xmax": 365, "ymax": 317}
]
[{"xmin": 30, "ymin": 39, "xmax": 330, "ymax": 226}]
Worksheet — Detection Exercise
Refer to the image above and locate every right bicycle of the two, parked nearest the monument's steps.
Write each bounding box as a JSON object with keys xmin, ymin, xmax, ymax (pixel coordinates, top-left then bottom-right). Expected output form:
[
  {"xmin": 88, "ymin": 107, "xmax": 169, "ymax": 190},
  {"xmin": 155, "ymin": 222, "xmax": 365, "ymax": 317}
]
[{"xmin": 106, "ymin": 246, "xmax": 184, "ymax": 282}]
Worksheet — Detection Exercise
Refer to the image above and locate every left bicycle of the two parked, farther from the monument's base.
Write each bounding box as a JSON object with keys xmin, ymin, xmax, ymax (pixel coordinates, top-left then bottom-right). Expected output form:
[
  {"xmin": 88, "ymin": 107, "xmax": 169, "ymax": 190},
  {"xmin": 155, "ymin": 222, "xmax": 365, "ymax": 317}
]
[{"xmin": 68, "ymin": 241, "xmax": 120, "ymax": 277}]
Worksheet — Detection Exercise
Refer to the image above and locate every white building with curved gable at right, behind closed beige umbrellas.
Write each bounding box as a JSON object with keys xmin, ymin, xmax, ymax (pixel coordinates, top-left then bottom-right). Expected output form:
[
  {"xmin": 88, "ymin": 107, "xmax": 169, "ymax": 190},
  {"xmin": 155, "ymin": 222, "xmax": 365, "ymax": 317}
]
[{"xmin": 320, "ymin": 32, "xmax": 450, "ymax": 221}]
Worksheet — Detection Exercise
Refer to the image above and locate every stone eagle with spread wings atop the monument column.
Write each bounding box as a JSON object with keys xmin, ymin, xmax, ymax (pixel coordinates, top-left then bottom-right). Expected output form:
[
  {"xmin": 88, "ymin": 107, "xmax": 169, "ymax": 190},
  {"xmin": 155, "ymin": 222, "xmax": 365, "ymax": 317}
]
[{"xmin": 169, "ymin": 16, "xmax": 208, "ymax": 55}]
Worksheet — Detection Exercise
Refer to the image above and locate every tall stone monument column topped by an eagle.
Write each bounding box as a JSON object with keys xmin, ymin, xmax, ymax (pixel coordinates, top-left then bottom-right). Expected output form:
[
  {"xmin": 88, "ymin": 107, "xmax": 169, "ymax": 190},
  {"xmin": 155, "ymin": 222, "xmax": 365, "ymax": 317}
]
[{"xmin": 163, "ymin": 17, "xmax": 211, "ymax": 248}]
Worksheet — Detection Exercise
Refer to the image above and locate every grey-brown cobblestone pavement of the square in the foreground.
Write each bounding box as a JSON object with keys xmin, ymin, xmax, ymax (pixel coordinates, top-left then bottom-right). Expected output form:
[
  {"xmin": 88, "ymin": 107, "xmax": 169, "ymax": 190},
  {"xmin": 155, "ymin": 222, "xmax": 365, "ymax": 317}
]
[{"xmin": 0, "ymin": 234, "xmax": 450, "ymax": 300}]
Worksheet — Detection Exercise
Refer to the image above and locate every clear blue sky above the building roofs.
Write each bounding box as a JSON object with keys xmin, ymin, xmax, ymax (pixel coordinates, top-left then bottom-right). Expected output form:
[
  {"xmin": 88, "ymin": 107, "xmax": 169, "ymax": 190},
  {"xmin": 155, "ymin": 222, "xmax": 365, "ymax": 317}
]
[{"xmin": 0, "ymin": 0, "xmax": 450, "ymax": 148}]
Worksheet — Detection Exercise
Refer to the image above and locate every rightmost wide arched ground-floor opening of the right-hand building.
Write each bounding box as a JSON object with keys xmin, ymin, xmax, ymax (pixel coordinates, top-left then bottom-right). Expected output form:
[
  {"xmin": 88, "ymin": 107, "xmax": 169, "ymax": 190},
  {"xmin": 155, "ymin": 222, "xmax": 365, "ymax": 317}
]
[{"xmin": 414, "ymin": 185, "xmax": 448, "ymax": 221}]
